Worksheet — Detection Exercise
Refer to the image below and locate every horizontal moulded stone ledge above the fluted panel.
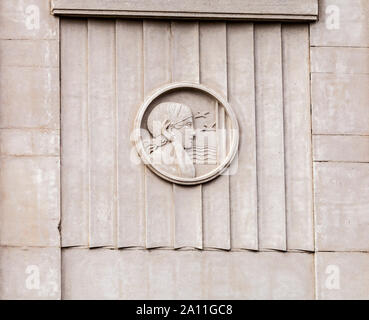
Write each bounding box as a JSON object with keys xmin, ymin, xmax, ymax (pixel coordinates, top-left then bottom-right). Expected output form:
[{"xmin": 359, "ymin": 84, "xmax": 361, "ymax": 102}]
[{"xmin": 51, "ymin": 0, "xmax": 318, "ymax": 22}]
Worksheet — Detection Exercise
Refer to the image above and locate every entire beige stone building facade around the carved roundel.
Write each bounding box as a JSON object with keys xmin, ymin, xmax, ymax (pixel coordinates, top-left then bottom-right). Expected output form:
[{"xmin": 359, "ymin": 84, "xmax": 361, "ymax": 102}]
[{"xmin": 0, "ymin": 0, "xmax": 369, "ymax": 299}]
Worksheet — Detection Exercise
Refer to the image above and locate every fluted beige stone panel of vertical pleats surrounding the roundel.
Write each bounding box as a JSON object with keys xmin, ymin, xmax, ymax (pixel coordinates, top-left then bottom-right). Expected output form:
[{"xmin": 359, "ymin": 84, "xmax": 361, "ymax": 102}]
[{"xmin": 61, "ymin": 19, "xmax": 313, "ymax": 255}]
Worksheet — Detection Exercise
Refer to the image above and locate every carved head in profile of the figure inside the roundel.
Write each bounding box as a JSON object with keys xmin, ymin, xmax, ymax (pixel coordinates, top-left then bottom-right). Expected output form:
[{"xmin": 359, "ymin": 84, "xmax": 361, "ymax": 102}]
[{"xmin": 147, "ymin": 102, "xmax": 195, "ymax": 149}]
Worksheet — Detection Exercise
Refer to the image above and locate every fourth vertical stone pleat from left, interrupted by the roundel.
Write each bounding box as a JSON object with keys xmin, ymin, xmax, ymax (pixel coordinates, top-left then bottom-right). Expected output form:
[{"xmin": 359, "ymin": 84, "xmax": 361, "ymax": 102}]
[{"xmin": 143, "ymin": 20, "xmax": 174, "ymax": 248}]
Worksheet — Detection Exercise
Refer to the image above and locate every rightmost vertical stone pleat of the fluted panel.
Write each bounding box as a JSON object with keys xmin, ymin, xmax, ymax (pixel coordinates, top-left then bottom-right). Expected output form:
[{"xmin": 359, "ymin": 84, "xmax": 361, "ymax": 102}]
[{"xmin": 282, "ymin": 25, "xmax": 314, "ymax": 251}]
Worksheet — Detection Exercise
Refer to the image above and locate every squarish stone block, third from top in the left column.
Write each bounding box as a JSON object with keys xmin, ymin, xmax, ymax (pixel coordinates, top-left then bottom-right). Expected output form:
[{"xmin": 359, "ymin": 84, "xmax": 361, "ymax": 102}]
[{"xmin": 0, "ymin": 67, "xmax": 60, "ymax": 129}]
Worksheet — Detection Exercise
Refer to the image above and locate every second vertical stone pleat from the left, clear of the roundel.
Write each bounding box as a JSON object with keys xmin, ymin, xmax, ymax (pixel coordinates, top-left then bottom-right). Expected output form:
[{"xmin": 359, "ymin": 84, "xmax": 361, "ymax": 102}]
[{"xmin": 88, "ymin": 19, "xmax": 116, "ymax": 247}]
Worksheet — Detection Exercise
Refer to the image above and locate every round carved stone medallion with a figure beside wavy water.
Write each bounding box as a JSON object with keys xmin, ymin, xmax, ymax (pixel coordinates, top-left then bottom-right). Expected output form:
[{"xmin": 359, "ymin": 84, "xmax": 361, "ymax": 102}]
[{"xmin": 133, "ymin": 82, "xmax": 239, "ymax": 185}]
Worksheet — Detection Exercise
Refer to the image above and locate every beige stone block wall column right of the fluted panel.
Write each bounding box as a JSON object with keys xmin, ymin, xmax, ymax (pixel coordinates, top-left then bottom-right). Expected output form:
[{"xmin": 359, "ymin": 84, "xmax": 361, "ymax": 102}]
[{"xmin": 310, "ymin": 0, "xmax": 369, "ymax": 299}]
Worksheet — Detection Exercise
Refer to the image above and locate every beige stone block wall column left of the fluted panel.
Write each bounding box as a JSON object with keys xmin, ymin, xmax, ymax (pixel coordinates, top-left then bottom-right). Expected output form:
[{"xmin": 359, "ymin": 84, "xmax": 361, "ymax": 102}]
[{"xmin": 0, "ymin": 0, "xmax": 61, "ymax": 299}]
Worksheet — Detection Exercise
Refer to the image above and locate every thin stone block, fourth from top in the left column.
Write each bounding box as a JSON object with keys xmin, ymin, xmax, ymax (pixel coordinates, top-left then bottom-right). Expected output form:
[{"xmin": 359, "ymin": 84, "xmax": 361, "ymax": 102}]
[{"xmin": 0, "ymin": 129, "xmax": 59, "ymax": 156}]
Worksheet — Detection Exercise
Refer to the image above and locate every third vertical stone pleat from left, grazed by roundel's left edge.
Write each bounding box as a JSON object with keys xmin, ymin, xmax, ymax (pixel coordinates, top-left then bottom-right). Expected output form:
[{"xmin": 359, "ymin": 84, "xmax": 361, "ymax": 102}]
[{"xmin": 116, "ymin": 20, "xmax": 145, "ymax": 248}]
